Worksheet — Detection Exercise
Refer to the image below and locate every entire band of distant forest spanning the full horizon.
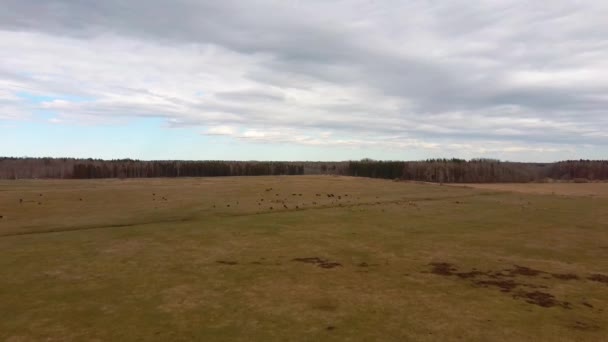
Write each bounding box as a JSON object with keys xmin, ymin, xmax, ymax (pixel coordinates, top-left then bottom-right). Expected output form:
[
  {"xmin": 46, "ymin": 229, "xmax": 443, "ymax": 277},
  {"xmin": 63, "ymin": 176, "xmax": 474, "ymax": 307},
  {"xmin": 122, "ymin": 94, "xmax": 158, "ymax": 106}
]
[{"xmin": 0, "ymin": 157, "xmax": 608, "ymax": 183}]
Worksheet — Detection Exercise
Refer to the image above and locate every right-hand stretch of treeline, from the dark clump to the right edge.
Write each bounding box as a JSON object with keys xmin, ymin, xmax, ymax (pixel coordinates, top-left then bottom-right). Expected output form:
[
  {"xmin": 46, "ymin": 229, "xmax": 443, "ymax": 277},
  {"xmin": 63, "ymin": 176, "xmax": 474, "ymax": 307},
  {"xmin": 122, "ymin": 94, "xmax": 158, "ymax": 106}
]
[{"xmin": 347, "ymin": 159, "xmax": 608, "ymax": 183}]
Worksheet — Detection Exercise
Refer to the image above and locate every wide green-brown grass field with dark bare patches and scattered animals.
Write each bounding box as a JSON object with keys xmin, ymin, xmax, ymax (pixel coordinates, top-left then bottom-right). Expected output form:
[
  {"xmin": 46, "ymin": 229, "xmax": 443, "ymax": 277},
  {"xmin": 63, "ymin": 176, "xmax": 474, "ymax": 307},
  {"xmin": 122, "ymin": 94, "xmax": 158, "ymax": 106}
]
[{"xmin": 0, "ymin": 176, "xmax": 608, "ymax": 341}]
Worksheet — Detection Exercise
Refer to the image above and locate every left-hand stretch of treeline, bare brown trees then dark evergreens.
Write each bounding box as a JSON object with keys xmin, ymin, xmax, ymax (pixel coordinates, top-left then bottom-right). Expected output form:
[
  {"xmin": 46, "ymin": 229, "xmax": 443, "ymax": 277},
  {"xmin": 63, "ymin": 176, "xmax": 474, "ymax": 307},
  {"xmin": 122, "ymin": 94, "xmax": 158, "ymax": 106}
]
[{"xmin": 0, "ymin": 158, "xmax": 304, "ymax": 179}]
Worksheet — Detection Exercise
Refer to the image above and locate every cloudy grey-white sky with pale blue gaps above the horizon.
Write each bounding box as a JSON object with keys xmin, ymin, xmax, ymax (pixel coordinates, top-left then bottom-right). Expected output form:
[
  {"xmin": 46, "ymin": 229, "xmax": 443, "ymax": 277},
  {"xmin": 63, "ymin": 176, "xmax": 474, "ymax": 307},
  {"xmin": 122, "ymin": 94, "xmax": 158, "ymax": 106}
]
[{"xmin": 0, "ymin": 0, "xmax": 608, "ymax": 162}]
